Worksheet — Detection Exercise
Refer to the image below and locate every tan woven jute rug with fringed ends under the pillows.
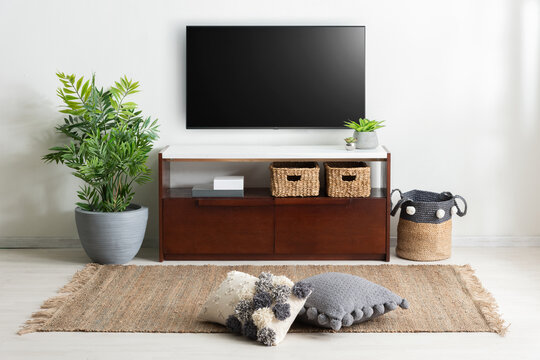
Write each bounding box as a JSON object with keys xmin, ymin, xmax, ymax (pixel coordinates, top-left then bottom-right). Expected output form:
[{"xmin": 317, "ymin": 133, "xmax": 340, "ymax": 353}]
[{"xmin": 19, "ymin": 264, "xmax": 506, "ymax": 334}]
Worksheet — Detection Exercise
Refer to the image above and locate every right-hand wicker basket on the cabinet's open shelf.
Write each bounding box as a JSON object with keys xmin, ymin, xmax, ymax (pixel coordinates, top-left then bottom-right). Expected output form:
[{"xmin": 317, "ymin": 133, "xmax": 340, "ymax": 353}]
[{"xmin": 324, "ymin": 161, "xmax": 371, "ymax": 197}]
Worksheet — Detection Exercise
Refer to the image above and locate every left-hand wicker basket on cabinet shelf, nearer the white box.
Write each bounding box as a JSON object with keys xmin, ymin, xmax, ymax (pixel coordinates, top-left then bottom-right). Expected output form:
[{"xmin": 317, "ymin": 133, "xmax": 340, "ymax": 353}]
[{"xmin": 270, "ymin": 162, "xmax": 320, "ymax": 197}]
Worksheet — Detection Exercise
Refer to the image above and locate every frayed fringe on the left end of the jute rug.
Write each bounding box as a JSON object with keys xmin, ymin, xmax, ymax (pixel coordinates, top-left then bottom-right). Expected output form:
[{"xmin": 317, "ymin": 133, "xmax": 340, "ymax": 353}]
[{"xmin": 17, "ymin": 264, "xmax": 101, "ymax": 335}]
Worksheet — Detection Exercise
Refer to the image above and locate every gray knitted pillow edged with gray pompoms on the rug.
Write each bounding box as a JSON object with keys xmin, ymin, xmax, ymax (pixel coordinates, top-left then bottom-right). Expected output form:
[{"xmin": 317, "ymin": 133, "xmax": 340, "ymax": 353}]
[{"xmin": 297, "ymin": 272, "xmax": 409, "ymax": 331}]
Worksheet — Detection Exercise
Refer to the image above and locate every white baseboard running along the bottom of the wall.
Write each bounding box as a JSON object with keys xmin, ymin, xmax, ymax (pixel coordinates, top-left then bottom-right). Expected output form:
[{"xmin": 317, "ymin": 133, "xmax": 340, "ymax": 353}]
[{"xmin": 0, "ymin": 236, "xmax": 540, "ymax": 249}]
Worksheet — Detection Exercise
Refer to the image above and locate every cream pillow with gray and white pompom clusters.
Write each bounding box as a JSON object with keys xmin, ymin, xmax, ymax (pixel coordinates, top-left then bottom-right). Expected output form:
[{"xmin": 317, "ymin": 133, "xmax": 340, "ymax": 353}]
[{"xmin": 199, "ymin": 271, "xmax": 311, "ymax": 346}]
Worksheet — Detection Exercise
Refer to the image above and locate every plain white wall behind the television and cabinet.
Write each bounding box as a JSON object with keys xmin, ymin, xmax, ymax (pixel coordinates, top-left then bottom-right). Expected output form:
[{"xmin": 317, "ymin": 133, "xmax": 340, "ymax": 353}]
[{"xmin": 0, "ymin": 0, "xmax": 540, "ymax": 245}]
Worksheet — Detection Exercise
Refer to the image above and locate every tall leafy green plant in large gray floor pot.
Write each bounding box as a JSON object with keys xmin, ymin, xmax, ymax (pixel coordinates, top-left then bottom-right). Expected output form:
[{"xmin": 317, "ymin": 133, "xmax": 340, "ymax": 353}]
[{"xmin": 43, "ymin": 73, "xmax": 158, "ymax": 264}]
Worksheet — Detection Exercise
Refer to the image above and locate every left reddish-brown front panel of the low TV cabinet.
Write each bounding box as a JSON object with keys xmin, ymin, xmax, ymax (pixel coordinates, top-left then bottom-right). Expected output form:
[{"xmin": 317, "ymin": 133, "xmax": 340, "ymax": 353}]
[{"xmin": 163, "ymin": 198, "xmax": 274, "ymax": 254}]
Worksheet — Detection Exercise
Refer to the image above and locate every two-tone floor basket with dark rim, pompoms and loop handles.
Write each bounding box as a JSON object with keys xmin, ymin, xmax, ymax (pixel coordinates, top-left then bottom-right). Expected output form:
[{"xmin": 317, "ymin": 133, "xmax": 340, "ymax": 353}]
[{"xmin": 391, "ymin": 189, "xmax": 467, "ymax": 261}]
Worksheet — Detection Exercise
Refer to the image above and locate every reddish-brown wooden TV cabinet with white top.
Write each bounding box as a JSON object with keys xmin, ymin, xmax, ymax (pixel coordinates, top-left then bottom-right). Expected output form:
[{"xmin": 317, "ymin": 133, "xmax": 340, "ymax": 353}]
[{"xmin": 159, "ymin": 145, "xmax": 390, "ymax": 261}]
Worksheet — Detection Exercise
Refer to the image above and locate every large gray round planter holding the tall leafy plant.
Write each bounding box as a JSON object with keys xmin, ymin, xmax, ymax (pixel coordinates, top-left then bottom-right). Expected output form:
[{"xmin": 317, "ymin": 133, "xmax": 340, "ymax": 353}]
[{"xmin": 75, "ymin": 204, "xmax": 148, "ymax": 264}]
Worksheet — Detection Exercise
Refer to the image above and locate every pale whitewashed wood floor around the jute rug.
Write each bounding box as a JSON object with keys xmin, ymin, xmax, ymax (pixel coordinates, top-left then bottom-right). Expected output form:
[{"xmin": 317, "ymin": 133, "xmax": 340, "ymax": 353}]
[{"xmin": 0, "ymin": 247, "xmax": 540, "ymax": 360}]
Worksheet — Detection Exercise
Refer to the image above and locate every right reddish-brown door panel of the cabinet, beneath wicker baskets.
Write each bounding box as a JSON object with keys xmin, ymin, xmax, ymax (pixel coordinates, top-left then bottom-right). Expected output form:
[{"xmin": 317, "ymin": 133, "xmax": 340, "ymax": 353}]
[{"xmin": 275, "ymin": 198, "xmax": 386, "ymax": 255}]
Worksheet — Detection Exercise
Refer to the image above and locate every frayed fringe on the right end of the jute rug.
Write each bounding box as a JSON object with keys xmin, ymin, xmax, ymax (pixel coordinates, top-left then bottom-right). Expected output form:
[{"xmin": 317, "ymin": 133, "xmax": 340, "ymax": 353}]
[{"xmin": 455, "ymin": 265, "xmax": 510, "ymax": 336}]
